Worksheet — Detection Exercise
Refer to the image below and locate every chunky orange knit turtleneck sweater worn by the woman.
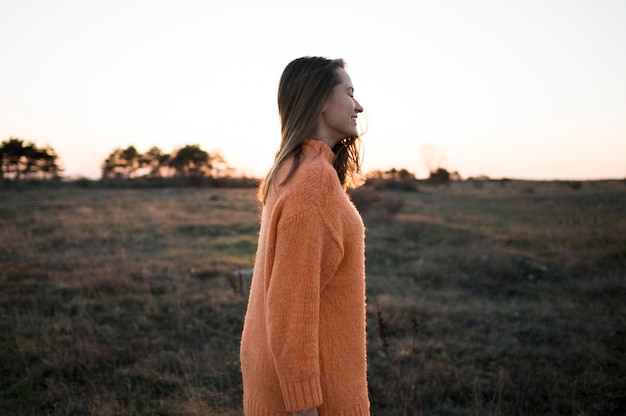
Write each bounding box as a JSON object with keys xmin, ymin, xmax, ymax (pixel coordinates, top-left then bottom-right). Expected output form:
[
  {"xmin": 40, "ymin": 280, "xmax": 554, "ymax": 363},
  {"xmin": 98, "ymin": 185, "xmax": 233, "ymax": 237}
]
[{"xmin": 240, "ymin": 140, "xmax": 369, "ymax": 416}]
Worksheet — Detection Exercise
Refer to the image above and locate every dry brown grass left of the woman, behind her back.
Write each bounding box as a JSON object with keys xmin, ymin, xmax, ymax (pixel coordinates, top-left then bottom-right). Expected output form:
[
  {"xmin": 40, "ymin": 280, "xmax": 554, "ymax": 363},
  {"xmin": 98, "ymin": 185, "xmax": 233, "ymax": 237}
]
[{"xmin": 0, "ymin": 188, "xmax": 258, "ymax": 415}]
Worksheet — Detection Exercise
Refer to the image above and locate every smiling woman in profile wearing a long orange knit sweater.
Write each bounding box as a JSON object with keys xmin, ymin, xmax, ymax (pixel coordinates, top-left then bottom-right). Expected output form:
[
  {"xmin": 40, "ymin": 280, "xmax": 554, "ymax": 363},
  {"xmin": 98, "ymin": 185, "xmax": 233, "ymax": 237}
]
[{"xmin": 240, "ymin": 57, "xmax": 369, "ymax": 416}]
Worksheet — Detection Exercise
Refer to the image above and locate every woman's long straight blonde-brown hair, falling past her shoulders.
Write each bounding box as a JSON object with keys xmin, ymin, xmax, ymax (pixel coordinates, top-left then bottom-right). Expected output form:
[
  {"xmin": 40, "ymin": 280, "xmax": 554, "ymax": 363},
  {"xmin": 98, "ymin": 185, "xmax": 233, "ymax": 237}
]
[{"xmin": 259, "ymin": 57, "xmax": 364, "ymax": 203}]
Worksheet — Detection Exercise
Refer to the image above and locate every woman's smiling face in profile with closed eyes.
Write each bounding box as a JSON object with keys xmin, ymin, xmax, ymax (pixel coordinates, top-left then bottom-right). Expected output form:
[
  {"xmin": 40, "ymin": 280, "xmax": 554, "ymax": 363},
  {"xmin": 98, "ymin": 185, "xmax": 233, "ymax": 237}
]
[{"xmin": 314, "ymin": 68, "xmax": 363, "ymax": 148}]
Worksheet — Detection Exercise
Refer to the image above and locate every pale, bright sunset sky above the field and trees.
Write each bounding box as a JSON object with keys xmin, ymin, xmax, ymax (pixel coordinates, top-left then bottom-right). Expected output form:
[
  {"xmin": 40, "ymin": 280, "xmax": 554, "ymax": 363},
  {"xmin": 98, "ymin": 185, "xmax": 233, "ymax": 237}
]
[{"xmin": 0, "ymin": 0, "xmax": 626, "ymax": 180}]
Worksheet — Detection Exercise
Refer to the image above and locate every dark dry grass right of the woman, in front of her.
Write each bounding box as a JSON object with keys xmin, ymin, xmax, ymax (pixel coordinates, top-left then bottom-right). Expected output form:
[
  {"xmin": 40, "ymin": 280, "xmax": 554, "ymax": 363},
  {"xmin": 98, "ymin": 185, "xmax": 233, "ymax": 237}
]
[{"xmin": 366, "ymin": 182, "xmax": 626, "ymax": 415}]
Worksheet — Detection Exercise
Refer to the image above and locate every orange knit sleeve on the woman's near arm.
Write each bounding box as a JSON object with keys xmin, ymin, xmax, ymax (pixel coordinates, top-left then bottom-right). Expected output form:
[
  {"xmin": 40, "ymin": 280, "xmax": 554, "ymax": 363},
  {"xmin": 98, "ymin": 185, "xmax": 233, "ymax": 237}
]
[{"xmin": 265, "ymin": 207, "xmax": 341, "ymax": 411}]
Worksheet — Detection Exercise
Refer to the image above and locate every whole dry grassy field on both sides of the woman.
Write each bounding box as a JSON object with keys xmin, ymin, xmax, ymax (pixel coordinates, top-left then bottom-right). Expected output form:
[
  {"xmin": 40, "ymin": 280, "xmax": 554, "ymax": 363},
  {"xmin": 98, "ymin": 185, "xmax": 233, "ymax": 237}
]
[{"xmin": 0, "ymin": 181, "xmax": 626, "ymax": 416}]
